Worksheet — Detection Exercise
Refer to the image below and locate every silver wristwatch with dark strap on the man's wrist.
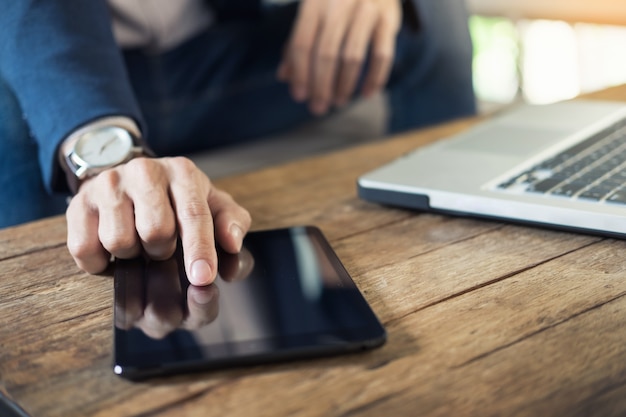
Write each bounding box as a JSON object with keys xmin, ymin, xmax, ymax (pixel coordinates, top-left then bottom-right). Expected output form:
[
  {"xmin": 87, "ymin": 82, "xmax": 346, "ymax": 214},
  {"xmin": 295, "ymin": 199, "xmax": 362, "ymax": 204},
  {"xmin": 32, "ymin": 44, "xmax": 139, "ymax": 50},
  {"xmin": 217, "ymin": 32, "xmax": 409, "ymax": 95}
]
[{"xmin": 59, "ymin": 117, "xmax": 148, "ymax": 194}]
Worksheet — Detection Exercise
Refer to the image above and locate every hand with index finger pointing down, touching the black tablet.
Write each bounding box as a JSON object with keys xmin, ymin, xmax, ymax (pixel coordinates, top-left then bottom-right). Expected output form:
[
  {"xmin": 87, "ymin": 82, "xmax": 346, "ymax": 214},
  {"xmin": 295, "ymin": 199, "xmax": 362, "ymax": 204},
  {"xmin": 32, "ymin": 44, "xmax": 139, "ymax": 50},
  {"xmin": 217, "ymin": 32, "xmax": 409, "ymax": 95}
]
[{"xmin": 66, "ymin": 157, "xmax": 251, "ymax": 285}]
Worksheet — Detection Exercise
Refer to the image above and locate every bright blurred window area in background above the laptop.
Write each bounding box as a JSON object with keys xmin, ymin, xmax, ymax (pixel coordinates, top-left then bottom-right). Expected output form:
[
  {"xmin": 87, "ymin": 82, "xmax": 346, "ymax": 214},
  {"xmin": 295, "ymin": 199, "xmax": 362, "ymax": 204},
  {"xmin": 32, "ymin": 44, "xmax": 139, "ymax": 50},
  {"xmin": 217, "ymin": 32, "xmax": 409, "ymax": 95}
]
[{"xmin": 467, "ymin": 0, "xmax": 626, "ymax": 109}]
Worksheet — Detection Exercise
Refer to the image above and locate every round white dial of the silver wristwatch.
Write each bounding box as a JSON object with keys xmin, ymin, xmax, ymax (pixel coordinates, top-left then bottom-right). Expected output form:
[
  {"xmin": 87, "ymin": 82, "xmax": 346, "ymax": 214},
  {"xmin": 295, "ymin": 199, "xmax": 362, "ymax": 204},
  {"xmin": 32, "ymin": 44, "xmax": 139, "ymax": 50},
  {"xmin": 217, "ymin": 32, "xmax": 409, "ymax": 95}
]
[{"xmin": 74, "ymin": 127, "xmax": 133, "ymax": 168}]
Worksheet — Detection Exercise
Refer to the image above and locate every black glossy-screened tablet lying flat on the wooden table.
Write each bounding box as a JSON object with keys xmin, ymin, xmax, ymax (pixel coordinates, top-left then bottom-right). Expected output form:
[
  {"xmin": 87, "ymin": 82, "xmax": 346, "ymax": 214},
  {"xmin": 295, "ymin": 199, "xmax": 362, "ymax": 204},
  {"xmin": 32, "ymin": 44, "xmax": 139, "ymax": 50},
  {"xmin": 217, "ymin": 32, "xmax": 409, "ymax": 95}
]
[{"xmin": 113, "ymin": 226, "xmax": 386, "ymax": 380}]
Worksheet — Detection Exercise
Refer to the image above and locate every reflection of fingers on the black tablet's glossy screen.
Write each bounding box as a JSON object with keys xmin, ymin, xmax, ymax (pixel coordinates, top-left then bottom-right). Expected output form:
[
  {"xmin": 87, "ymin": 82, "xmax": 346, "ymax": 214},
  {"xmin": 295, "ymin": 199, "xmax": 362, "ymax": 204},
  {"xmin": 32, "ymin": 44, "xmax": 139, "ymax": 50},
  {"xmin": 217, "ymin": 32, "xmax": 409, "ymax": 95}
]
[{"xmin": 115, "ymin": 247, "xmax": 254, "ymax": 339}]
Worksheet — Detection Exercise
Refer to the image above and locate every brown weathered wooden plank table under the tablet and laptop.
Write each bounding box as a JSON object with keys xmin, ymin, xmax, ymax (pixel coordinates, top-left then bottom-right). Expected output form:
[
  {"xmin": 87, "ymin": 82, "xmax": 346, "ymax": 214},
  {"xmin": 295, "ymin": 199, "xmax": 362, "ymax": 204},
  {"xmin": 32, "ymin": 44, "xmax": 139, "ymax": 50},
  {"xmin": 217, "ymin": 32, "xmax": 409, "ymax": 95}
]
[{"xmin": 0, "ymin": 87, "xmax": 626, "ymax": 417}]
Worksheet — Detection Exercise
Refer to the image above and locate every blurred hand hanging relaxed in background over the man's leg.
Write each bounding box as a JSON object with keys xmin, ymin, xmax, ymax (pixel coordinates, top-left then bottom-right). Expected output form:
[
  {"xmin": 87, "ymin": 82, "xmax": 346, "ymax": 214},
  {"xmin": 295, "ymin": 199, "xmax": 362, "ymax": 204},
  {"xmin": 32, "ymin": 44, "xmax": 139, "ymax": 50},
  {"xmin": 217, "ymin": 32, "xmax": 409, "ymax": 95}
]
[{"xmin": 278, "ymin": 0, "xmax": 402, "ymax": 115}]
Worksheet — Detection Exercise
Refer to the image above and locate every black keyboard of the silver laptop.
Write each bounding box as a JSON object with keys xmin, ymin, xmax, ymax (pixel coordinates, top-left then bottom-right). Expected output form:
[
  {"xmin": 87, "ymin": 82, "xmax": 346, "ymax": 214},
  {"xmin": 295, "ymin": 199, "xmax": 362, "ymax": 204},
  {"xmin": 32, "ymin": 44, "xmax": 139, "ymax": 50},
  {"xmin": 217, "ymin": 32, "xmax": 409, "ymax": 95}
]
[{"xmin": 498, "ymin": 118, "xmax": 626, "ymax": 204}]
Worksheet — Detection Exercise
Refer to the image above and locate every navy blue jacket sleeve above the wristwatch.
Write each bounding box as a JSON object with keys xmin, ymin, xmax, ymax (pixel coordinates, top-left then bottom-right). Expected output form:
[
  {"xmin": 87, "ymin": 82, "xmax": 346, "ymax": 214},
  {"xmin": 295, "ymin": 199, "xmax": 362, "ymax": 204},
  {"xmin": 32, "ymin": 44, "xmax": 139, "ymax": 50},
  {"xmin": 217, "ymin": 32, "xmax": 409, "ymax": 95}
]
[{"xmin": 0, "ymin": 0, "xmax": 143, "ymax": 191}]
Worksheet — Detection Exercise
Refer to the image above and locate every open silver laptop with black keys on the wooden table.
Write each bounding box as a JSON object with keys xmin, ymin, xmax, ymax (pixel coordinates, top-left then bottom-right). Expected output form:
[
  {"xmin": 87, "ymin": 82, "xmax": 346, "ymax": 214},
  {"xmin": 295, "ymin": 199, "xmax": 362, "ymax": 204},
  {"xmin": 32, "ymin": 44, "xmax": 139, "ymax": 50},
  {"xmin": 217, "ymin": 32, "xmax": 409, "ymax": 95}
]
[{"xmin": 357, "ymin": 100, "xmax": 626, "ymax": 238}]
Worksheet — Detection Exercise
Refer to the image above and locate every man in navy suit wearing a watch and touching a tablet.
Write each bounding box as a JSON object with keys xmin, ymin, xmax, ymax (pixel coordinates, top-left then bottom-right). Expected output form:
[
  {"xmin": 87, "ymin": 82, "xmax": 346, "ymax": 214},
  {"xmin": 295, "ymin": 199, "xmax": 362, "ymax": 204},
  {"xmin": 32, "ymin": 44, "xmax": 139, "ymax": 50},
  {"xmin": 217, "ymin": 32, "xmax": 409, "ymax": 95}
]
[{"xmin": 0, "ymin": 0, "xmax": 475, "ymax": 285}]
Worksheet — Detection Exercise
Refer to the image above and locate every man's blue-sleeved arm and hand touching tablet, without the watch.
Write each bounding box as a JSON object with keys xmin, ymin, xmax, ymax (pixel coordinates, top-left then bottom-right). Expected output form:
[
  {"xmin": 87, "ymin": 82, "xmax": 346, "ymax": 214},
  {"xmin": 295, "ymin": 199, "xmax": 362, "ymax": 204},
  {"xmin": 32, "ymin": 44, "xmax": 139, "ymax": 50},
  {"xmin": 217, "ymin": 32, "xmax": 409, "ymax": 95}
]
[{"xmin": 0, "ymin": 0, "xmax": 250, "ymax": 285}]
